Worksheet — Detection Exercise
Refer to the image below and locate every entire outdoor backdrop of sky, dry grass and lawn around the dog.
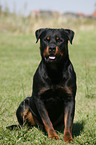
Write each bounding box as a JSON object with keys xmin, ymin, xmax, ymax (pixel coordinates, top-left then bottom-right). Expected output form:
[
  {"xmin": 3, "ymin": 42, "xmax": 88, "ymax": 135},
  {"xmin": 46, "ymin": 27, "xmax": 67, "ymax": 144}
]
[{"xmin": 0, "ymin": 0, "xmax": 96, "ymax": 145}]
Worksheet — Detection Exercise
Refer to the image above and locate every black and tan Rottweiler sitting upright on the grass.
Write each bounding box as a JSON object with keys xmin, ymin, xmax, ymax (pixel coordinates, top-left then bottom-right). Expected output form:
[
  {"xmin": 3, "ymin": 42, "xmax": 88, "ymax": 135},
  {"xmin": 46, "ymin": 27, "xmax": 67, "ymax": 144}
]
[{"xmin": 16, "ymin": 28, "xmax": 76, "ymax": 142}]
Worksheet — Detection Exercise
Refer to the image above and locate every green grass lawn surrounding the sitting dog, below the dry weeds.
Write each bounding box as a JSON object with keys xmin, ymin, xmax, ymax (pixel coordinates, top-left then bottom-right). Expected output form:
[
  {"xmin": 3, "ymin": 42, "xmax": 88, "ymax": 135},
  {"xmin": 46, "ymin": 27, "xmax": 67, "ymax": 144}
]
[{"xmin": 0, "ymin": 30, "xmax": 96, "ymax": 145}]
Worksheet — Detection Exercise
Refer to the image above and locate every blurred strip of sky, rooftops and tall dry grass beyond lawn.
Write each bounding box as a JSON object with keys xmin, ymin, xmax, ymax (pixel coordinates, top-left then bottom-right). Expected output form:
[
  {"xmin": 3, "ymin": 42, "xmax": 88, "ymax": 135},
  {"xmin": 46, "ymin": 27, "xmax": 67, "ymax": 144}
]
[{"xmin": 0, "ymin": 0, "xmax": 96, "ymax": 34}]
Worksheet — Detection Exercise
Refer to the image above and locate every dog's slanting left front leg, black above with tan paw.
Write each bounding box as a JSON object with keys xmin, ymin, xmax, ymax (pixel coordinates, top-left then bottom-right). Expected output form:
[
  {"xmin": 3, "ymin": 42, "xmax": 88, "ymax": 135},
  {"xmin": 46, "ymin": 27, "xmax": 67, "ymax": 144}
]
[{"xmin": 36, "ymin": 99, "xmax": 60, "ymax": 140}]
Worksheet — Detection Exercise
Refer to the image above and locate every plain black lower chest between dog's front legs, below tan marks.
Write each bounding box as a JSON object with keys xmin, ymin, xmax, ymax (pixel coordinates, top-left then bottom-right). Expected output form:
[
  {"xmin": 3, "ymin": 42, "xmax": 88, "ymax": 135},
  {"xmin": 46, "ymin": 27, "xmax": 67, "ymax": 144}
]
[{"xmin": 40, "ymin": 87, "xmax": 67, "ymax": 119}]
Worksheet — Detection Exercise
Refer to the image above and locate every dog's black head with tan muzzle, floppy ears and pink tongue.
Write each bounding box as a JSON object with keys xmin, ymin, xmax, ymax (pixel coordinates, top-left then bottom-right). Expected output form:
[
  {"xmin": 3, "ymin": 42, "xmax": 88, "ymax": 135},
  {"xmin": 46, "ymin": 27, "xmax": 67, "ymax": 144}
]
[{"xmin": 35, "ymin": 28, "xmax": 74, "ymax": 62}]
